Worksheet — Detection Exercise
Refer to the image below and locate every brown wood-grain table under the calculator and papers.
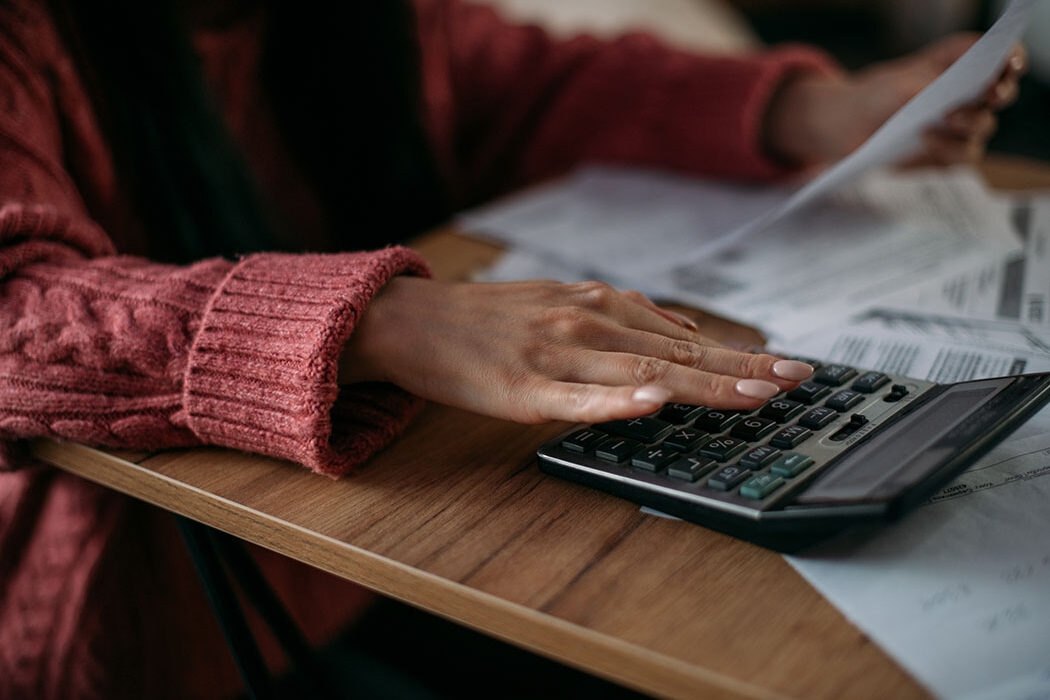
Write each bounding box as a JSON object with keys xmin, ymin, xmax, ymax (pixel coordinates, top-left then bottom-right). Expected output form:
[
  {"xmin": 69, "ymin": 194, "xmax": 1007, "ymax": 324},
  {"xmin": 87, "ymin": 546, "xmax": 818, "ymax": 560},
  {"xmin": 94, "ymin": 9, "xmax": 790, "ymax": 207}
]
[{"xmin": 34, "ymin": 158, "xmax": 1050, "ymax": 698}]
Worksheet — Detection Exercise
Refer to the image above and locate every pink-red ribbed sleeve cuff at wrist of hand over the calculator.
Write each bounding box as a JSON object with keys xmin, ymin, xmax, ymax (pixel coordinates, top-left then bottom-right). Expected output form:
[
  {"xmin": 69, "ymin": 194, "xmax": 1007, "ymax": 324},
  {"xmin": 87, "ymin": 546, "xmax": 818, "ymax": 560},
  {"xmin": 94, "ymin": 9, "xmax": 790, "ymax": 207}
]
[{"xmin": 184, "ymin": 248, "xmax": 429, "ymax": 476}]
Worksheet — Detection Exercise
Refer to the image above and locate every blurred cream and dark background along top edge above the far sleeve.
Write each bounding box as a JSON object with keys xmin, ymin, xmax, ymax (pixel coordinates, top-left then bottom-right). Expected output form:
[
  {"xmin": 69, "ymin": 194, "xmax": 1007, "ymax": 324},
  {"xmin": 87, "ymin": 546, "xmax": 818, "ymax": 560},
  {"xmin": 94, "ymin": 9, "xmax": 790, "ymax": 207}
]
[{"xmin": 473, "ymin": 0, "xmax": 1050, "ymax": 161}]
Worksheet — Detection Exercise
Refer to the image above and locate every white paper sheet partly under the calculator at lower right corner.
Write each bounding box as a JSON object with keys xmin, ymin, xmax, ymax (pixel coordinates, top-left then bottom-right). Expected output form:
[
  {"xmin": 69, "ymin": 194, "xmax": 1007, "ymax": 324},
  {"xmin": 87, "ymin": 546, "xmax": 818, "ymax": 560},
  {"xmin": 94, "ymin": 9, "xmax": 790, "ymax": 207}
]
[{"xmin": 786, "ymin": 432, "xmax": 1050, "ymax": 700}]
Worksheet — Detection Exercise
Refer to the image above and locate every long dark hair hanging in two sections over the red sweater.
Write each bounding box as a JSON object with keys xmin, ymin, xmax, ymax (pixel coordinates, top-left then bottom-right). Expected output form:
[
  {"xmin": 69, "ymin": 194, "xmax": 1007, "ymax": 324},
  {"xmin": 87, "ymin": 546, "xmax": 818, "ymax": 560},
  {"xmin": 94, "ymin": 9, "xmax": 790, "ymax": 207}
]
[{"xmin": 53, "ymin": 0, "xmax": 445, "ymax": 262}]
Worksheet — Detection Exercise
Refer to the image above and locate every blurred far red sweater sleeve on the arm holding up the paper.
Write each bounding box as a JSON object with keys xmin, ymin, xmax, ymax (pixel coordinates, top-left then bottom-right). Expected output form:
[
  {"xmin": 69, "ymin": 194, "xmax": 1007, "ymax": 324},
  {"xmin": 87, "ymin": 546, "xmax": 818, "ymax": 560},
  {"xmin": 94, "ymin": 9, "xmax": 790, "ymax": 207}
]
[{"xmin": 417, "ymin": 0, "xmax": 838, "ymax": 200}]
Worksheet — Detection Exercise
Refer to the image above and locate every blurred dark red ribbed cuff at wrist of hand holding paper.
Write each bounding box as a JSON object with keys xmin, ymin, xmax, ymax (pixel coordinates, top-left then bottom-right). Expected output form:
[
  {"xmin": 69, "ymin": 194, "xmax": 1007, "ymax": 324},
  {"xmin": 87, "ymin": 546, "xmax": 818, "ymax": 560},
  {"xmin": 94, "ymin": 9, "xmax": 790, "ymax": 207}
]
[{"xmin": 656, "ymin": 44, "xmax": 841, "ymax": 178}]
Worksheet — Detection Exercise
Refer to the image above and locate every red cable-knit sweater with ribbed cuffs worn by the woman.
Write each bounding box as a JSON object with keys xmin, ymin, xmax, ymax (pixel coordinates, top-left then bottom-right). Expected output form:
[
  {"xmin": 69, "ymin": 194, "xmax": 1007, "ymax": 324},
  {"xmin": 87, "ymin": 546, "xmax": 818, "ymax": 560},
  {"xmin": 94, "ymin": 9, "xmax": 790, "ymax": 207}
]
[{"xmin": 0, "ymin": 0, "xmax": 827, "ymax": 698}]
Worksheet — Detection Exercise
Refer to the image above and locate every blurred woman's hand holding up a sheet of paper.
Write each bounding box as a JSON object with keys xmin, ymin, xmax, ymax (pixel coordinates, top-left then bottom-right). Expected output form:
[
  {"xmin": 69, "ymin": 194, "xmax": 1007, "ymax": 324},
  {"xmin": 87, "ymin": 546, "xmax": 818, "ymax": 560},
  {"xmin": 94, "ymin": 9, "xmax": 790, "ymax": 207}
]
[{"xmin": 765, "ymin": 34, "xmax": 1027, "ymax": 166}]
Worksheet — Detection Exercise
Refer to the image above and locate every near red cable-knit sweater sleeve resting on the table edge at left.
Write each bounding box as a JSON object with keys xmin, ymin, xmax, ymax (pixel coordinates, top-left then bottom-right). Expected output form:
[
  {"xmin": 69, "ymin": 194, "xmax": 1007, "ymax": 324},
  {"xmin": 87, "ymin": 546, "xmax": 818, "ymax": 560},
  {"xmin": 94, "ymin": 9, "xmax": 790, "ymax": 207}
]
[{"xmin": 0, "ymin": 1, "xmax": 427, "ymax": 475}]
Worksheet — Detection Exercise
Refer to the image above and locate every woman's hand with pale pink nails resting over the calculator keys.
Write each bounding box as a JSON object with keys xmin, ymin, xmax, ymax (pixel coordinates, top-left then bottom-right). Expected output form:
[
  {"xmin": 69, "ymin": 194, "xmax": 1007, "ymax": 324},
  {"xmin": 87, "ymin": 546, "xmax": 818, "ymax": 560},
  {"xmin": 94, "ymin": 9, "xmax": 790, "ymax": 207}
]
[{"xmin": 339, "ymin": 277, "xmax": 813, "ymax": 423}]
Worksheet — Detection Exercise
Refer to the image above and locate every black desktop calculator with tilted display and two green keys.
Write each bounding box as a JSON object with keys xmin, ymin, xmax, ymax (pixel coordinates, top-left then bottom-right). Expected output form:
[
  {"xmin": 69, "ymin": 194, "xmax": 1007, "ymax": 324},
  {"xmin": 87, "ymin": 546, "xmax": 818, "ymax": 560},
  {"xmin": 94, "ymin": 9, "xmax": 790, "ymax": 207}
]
[{"xmin": 538, "ymin": 358, "xmax": 1050, "ymax": 551}]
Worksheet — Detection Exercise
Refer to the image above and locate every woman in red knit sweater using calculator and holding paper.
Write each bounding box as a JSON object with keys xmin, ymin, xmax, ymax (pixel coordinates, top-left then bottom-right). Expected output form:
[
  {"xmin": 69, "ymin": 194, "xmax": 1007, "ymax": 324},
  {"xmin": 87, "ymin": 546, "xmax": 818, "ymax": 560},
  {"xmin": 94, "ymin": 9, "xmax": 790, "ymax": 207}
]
[{"xmin": 0, "ymin": 0, "xmax": 1024, "ymax": 698}]
